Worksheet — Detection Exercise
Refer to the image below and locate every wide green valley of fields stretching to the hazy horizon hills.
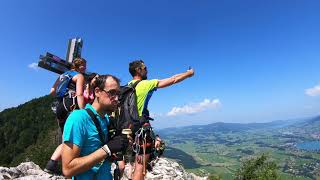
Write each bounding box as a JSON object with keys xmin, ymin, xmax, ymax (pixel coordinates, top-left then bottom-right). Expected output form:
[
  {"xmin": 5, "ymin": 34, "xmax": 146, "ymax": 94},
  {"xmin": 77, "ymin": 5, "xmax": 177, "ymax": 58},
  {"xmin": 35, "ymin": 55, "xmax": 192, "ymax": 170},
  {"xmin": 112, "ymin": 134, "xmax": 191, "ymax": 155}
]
[{"xmin": 160, "ymin": 120, "xmax": 320, "ymax": 179}]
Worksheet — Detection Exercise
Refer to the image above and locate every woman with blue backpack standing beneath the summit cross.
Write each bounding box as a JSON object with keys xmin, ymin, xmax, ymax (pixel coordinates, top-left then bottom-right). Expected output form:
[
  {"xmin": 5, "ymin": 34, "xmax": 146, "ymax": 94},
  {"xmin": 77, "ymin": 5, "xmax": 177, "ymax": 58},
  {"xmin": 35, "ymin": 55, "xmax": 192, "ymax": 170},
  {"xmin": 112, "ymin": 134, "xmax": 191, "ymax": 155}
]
[{"xmin": 45, "ymin": 58, "xmax": 86, "ymax": 174}]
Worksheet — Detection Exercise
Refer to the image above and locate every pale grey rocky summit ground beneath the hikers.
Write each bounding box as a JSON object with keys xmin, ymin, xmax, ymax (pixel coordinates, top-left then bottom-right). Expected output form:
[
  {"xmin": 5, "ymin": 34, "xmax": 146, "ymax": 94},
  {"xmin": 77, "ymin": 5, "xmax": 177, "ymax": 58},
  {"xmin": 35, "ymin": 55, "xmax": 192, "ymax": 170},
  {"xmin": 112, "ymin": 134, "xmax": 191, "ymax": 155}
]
[{"xmin": 0, "ymin": 158, "xmax": 207, "ymax": 180}]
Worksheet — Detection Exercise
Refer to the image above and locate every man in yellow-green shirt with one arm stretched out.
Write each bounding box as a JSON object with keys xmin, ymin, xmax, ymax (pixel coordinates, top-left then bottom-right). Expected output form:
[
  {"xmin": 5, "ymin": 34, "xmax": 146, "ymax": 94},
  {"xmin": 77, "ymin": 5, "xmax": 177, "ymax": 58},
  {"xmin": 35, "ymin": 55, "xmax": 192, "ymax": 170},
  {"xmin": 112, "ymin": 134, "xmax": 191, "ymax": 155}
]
[{"xmin": 124, "ymin": 60, "xmax": 194, "ymax": 180}]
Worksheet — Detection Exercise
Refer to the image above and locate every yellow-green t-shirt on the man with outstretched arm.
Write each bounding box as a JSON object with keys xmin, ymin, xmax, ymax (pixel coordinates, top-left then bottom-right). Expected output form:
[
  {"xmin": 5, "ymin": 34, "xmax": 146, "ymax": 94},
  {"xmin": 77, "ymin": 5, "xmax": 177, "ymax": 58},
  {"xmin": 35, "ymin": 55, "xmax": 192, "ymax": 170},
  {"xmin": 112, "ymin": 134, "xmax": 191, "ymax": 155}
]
[{"xmin": 128, "ymin": 79, "xmax": 158, "ymax": 116}]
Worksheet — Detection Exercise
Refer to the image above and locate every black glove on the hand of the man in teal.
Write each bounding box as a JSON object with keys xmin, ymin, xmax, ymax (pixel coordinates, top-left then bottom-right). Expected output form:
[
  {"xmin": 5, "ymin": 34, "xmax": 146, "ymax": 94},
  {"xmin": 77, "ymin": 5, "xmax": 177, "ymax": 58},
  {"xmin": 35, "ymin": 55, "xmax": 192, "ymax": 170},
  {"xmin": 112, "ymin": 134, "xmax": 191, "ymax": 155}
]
[{"xmin": 106, "ymin": 134, "xmax": 129, "ymax": 153}]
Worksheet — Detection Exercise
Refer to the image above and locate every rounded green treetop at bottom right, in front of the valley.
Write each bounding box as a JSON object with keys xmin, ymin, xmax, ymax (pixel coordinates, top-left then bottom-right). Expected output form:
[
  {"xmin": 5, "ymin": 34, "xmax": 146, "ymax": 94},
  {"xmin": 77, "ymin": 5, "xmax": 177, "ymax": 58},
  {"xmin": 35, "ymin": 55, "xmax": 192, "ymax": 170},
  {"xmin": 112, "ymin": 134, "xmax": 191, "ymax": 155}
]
[{"xmin": 236, "ymin": 154, "xmax": 279, "ymax": 180}]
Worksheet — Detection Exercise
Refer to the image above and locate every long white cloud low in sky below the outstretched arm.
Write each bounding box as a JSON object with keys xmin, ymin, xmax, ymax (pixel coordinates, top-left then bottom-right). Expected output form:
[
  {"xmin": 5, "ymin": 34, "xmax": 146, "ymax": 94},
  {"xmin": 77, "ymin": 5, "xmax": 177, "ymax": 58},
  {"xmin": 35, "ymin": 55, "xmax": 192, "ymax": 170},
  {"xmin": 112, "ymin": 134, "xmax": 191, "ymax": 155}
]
[{"xmin": 167, "ymin": 99, "xmax": 221, "ymax": 116}]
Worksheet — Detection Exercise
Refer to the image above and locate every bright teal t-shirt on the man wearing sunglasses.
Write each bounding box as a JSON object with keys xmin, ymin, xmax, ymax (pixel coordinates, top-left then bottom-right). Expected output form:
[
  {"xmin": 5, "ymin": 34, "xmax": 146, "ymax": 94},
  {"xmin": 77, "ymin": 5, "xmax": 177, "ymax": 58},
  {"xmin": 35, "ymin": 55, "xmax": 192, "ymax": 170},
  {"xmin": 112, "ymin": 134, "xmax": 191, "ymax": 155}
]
[{"xmin": 63, "ymin": 104, "xmax": 112, "ymax": 180}]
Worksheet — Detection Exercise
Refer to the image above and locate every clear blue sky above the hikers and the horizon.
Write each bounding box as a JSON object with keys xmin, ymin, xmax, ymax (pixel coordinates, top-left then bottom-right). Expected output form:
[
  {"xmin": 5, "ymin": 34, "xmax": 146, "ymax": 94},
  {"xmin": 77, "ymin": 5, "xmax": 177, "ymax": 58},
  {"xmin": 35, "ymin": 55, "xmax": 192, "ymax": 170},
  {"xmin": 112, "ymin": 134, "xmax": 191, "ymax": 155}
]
[{"xmin": 0, "ymin": 0, "xmax": 320, "ymax": 128}]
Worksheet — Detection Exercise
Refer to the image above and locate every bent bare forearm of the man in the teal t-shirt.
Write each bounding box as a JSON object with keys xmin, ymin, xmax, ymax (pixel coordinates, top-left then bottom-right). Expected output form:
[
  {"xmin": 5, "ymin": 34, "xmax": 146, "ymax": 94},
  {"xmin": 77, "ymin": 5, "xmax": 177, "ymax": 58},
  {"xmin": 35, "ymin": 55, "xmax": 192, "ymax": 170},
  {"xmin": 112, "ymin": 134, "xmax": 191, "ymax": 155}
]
[{"xmin": 62, "ymin": 142, "xmax": 107, "ymax": 177}]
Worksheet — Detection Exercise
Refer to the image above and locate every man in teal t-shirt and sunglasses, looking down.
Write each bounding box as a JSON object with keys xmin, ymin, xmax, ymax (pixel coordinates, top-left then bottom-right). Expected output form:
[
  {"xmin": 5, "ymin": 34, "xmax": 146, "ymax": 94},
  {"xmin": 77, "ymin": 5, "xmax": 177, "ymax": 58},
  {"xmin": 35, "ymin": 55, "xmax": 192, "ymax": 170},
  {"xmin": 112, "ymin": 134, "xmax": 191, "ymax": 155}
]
[{"xmin": 62, "ymin": 75, "xmax": 128, "ymax": 180}]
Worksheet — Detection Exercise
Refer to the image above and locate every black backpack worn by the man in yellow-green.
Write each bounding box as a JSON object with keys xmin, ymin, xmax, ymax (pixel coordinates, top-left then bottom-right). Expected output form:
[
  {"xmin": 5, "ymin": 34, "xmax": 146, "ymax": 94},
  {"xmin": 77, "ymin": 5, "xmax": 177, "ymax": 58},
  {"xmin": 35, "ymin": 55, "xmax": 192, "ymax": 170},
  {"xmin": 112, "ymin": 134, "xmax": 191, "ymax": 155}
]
[{"xmin": 112, "ymin": 80, "xmax": 144, "ymax": 135}]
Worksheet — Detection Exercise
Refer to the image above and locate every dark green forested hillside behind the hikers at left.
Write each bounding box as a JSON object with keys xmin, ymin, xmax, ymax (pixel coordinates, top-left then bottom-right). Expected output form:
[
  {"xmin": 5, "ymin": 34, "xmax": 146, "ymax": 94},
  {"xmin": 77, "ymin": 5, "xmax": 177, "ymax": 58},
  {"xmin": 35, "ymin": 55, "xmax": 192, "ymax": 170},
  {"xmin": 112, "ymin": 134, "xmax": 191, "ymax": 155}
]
[{"xmin": 0, "ymin": 96, "xmax": 58, "ymax": 167}]
